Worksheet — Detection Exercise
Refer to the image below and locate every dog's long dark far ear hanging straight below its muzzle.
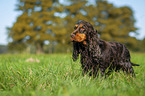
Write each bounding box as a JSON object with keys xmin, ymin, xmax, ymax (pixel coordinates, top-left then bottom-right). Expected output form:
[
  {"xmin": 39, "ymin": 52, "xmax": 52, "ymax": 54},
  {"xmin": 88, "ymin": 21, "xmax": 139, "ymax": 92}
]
[{"xmin": 72, "ymin": 42, "xmax": 80, "ymax": 61}]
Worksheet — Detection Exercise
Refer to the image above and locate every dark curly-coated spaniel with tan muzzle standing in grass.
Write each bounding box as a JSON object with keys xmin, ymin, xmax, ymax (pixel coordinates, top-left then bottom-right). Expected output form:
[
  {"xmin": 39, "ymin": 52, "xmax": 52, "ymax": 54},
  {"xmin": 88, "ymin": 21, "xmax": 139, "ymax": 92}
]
[{"xmin": 71, "ymin": 20, "xmax": 139, "ymax": 77}]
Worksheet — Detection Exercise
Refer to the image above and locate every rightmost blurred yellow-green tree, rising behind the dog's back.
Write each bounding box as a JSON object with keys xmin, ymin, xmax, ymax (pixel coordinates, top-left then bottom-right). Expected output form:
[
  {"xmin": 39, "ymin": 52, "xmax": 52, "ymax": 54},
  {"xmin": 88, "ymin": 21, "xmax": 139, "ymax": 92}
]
[{"xmin": 85, "ymin": 0, "xmax": 137, "ymax": 47}]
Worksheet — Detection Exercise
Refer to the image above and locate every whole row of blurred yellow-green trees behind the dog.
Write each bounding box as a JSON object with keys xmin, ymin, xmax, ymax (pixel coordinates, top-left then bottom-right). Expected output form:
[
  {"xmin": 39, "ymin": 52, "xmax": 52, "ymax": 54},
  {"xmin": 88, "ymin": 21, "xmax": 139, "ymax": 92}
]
[{"xmin": 7, "ymin": 0, "xmax": 145, "ymax": 54}]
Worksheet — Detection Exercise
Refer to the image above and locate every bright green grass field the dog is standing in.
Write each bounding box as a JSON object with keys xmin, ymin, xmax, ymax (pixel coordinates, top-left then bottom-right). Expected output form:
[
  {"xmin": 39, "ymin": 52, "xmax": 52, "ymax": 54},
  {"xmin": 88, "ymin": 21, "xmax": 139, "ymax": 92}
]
[{"xmin": 0, "ymin": 53, "xmax": 145, "ymax": 96}]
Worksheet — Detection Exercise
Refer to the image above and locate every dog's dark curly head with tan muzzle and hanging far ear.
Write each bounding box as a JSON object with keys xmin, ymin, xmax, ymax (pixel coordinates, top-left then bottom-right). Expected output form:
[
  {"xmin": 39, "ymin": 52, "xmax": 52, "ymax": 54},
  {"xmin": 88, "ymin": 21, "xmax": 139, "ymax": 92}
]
[{"xmin": 70, "ymin": 20, "xmax": 97, "ymax": 60}]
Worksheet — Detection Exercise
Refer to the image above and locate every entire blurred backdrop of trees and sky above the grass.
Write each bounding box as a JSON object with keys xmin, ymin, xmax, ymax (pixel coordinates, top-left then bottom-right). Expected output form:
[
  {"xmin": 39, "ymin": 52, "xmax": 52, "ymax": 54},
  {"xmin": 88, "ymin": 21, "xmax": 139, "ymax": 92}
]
[{"xmin": 0, "ymin": 0, "xmax": 145, "ymax": 54}]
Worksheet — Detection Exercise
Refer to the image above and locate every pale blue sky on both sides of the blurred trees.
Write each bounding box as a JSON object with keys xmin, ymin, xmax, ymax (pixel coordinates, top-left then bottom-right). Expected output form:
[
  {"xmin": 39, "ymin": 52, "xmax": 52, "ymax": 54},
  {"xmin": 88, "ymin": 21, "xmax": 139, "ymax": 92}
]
[{"xmin": 0, "ymin": 0, "xmax": 145, "ymax": 45}]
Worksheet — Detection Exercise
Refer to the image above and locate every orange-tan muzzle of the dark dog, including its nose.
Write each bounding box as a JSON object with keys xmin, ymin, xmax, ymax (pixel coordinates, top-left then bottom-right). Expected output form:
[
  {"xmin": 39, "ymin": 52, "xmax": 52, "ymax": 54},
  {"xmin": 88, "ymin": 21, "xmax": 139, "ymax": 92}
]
[{"xmin": 70, "ymin": 33, "xmax": 86, "ymax": 42}]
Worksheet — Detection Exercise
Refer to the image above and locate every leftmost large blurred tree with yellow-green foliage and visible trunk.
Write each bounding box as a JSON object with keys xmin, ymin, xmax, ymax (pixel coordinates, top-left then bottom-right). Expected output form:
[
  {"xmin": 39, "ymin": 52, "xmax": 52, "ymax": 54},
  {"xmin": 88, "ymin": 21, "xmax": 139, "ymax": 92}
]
[{"xmin": 9, "ymin": 0, "xmax": 61, "ymax": 54}]
